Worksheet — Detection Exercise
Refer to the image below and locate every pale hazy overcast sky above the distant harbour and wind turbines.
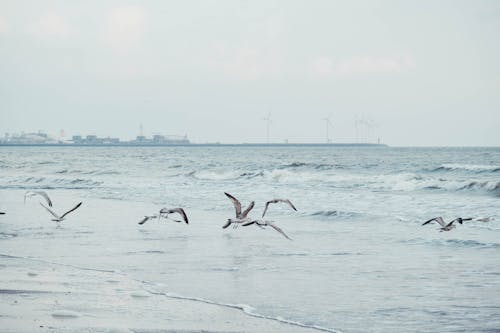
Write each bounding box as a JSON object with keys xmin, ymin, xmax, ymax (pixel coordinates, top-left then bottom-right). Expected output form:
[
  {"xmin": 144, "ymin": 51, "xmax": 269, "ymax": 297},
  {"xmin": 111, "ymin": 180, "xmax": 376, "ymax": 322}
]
[{"xmin": 0, "ymin": 0, "xmax": 500, "ymax": 146}]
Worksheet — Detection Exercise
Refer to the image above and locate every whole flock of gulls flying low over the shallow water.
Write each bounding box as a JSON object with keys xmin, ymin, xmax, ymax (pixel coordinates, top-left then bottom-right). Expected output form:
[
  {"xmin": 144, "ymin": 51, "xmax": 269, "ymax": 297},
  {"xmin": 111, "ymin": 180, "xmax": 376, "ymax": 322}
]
[{"xmin": 0, "ymin": 191, "xmax": 494, "ymax": 240}]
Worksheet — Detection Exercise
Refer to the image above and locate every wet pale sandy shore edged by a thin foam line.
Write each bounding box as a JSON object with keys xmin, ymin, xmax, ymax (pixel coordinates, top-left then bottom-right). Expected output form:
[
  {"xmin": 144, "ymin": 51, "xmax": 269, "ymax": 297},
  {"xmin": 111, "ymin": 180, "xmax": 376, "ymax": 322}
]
[{"xmin": 0, "ymin": 254, "xmax": 338, "ymax": 333}]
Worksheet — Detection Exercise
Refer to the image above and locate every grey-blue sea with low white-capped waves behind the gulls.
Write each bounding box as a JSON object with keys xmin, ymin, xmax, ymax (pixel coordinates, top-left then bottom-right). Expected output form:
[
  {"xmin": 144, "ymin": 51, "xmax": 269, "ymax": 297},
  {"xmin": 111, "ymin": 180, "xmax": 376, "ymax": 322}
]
[{"xmin": 0, "ymin": 145, "xmax": 500, "ymax": 332}]
